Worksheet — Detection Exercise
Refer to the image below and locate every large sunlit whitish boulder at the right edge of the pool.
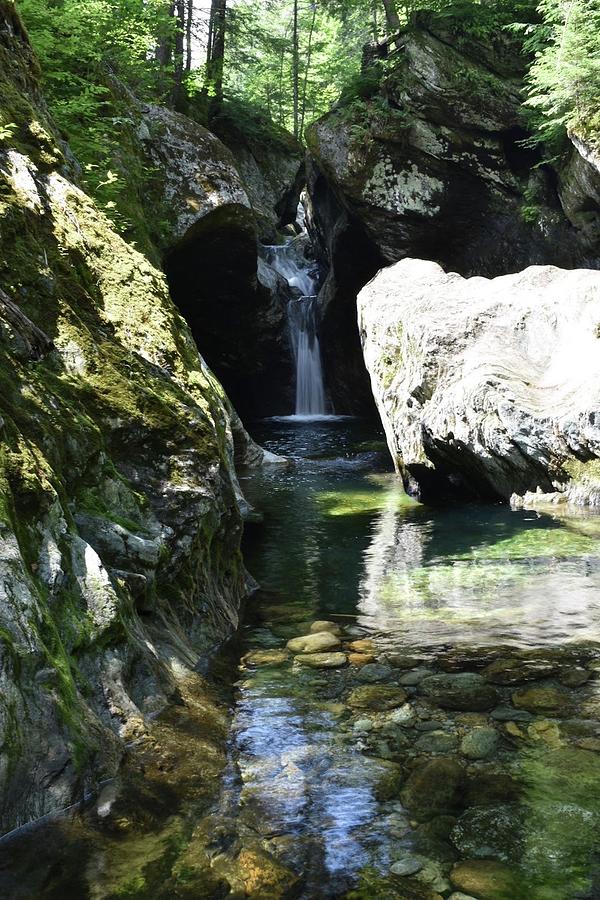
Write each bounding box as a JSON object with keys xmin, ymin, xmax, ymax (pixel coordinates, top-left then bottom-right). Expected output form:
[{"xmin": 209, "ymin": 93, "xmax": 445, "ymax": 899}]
[{"xmin": 358, "ymin": 260, "xmax": 600, "ymax": 498}]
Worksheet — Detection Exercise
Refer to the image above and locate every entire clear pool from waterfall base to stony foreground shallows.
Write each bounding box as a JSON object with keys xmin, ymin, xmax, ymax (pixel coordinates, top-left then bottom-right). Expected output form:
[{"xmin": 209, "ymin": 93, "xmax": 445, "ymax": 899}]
[{"xmin": 0, "ymin": 417, "xmax": 600, "ymax": 900}]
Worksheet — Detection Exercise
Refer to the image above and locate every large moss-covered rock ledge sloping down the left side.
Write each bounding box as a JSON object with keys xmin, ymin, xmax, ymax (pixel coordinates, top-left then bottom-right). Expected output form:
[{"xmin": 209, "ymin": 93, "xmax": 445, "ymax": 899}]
[{"xmin": 0, "ymin": 0, "xmax": 251, "ymax": 831}]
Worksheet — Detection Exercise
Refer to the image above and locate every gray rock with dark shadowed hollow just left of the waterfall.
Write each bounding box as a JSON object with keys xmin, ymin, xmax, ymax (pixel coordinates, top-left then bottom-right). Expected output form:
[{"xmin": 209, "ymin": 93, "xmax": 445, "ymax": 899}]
[{"xmin": 136, "ymin": 105, "xmax": 301, "ymax": 417}]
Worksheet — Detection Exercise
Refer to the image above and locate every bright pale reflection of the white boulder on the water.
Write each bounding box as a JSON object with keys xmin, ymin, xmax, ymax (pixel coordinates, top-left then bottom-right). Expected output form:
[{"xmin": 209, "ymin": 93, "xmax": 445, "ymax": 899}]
[{"xmin": 358, "ymin": 508, "xmax": 600, "ymax": 646}]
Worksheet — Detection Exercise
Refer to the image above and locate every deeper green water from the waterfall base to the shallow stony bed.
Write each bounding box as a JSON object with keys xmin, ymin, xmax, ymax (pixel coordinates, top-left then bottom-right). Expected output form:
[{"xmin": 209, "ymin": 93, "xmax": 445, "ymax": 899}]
[{"xmin": 243, "ymin": 419, "xmax": 600, "ymax": 647}]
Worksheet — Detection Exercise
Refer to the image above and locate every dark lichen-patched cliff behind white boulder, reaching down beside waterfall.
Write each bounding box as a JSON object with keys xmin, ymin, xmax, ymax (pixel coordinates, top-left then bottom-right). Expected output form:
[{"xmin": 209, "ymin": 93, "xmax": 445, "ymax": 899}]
[{"xmin": 307, "ymin": 13, "xmax": 600, "ymax": 412}]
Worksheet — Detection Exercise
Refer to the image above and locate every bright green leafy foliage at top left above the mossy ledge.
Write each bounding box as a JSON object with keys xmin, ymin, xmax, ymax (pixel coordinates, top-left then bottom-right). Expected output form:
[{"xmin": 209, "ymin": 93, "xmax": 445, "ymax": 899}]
[{"xmin": 18, "ymin": 0, "xmax": 173, "ymax": 236}]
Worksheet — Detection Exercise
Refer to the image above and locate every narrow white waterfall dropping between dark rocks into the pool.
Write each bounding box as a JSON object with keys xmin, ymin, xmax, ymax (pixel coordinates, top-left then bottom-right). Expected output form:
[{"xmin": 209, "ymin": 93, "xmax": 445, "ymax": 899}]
[{"xmin": 265, "ymin": 235, "xmax": 329, "ymax": 418}]
